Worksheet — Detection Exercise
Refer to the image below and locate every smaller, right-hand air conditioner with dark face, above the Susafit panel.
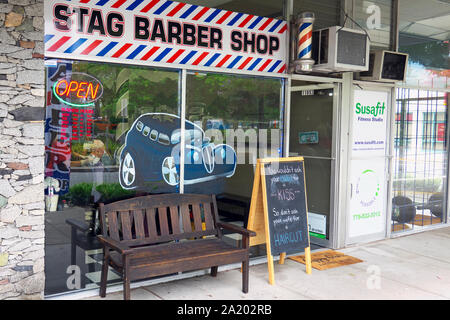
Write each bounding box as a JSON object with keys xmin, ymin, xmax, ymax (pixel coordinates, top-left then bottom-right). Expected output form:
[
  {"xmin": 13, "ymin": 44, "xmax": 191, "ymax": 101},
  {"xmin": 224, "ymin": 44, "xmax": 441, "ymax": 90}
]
[{"xmin": 359, "ymin": 50, "xmax": 408, "ymax": 82}]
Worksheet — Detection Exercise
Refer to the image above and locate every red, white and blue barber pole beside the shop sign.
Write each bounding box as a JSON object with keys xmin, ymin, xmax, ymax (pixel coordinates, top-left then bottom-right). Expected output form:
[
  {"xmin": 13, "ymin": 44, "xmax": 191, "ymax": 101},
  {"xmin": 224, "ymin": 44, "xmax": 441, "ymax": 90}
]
[{"xmin": 294, "ymin": 12, "xmax": 315, "ymax": 72}]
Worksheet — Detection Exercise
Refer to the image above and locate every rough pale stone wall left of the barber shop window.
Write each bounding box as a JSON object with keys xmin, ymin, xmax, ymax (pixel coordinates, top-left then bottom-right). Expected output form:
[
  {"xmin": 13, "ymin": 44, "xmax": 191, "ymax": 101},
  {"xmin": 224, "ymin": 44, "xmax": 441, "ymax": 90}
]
[{"xmin": 0, "ymin": 0, "xmax": 45, "ymax": 300}]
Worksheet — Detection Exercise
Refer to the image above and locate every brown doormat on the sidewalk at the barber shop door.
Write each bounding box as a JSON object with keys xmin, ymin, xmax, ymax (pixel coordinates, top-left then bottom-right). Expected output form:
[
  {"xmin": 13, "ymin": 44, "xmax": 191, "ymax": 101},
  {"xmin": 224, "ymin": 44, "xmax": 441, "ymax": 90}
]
[{"xmin": 289, "ymin": 250, "xmax": 363, "ymax": 270}]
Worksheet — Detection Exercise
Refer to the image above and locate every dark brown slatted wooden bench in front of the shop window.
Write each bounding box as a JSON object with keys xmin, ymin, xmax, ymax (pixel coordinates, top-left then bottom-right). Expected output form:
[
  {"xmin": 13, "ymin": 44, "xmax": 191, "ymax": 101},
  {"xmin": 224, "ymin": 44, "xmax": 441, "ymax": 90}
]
[{"xmin": 98, "ymin": 194, "xmax": 256, "ymax": 300}]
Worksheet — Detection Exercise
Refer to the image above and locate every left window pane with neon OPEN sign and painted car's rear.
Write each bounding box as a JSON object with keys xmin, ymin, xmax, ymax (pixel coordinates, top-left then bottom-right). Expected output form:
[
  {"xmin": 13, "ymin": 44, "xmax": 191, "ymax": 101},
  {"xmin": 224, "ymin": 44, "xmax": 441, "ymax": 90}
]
[{"xmin": 45, "ymin": 60, "xmax": 180, "ymax": 295}]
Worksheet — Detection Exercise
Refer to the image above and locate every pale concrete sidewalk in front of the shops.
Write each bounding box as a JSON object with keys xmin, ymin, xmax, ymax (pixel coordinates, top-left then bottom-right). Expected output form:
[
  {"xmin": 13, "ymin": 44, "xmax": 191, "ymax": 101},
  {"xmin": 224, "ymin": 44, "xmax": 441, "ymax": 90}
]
[{"xmin": 80, "ymin": 228, "xmax": 450, "ymax": 300}]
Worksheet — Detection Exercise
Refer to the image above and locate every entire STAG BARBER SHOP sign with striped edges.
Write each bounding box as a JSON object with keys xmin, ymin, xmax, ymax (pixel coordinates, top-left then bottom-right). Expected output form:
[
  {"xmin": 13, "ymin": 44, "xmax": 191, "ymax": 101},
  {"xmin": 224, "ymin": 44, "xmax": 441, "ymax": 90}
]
[{"xmin": 44, "ymin": 0, "xmax": 288, "ymax": 74}]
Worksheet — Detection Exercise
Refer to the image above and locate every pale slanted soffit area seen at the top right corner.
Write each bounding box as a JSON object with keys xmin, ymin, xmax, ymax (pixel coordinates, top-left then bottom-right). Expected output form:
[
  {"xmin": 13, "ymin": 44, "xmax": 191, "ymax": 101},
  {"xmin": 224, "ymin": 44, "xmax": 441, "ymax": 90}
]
[{"xmin": 399, "ymin": 0, "xmax": 450, "ymax": 40}]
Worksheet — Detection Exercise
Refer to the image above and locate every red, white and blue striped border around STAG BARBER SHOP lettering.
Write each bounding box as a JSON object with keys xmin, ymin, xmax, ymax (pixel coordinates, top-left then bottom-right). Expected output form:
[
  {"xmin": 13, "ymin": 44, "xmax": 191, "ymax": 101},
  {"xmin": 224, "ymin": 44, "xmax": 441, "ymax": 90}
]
[{"xmin": 44, "ymin": 0, "xmax": 288, "ymax": 74}]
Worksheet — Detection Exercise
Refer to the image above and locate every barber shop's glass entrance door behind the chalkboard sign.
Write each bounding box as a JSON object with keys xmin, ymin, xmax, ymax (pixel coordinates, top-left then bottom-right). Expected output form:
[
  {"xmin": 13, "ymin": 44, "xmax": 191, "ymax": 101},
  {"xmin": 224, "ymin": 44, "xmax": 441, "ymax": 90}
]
[{"xmin": 289, "ymin": 81, "xmax": 339, "ymax": 246}]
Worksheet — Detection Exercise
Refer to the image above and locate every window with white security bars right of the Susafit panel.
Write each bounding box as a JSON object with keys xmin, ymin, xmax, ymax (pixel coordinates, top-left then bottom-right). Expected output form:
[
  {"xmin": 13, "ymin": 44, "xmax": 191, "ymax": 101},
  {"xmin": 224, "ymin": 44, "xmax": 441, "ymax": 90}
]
[{"xmin": 392, "ymin": 88, "xmax": 448, "ymax": 232}]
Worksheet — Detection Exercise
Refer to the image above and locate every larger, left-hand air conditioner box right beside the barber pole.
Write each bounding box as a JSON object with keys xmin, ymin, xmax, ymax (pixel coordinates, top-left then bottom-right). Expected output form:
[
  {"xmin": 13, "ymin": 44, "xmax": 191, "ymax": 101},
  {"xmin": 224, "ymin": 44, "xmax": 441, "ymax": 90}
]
[{"xmin": 311, "ymin": 26, "xmax": 370, "ymax": 72}]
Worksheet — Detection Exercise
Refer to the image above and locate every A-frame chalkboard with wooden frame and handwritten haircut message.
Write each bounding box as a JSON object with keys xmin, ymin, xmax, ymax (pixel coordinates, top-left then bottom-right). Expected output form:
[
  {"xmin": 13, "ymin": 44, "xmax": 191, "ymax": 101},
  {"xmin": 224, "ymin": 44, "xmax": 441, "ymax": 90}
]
[{"xmin": 247, "ymin": 157, "xmax": 311, "ymax": 284}]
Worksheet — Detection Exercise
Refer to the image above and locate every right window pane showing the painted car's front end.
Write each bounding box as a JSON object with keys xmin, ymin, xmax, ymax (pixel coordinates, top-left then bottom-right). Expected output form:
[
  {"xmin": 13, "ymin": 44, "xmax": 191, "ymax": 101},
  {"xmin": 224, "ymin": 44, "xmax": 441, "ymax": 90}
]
[{"xmin": 184, "ymin": 73, "xmax": 284, "ymax": 244}]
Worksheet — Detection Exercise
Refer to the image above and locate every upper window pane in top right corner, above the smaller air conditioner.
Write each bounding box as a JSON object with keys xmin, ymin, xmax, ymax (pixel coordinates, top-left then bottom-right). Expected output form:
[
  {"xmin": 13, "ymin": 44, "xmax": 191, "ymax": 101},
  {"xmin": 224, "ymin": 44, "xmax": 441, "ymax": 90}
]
[{"xmin": 399, "ymin": 0, "xmax": 450, "ymax": 88}]
